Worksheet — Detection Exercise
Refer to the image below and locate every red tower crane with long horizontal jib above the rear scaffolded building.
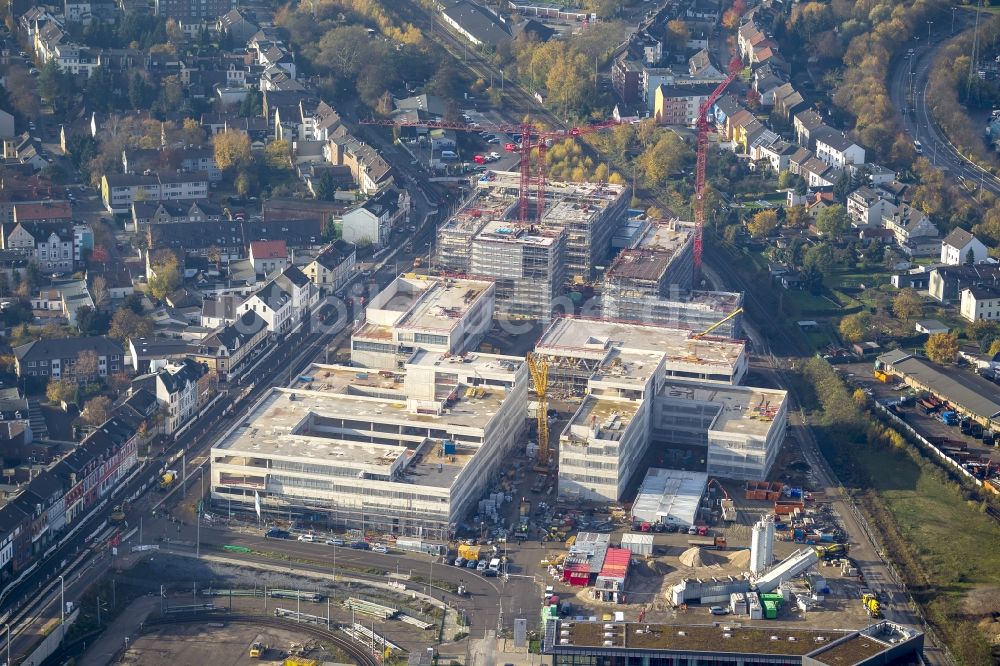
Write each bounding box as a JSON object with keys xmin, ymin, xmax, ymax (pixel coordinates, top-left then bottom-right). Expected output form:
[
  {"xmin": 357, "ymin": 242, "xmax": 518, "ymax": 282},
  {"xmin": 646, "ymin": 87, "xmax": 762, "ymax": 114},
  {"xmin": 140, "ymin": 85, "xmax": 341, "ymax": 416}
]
[{"xmin": 361, "ymin": 119, "xmax": 620, "ymax": 224}]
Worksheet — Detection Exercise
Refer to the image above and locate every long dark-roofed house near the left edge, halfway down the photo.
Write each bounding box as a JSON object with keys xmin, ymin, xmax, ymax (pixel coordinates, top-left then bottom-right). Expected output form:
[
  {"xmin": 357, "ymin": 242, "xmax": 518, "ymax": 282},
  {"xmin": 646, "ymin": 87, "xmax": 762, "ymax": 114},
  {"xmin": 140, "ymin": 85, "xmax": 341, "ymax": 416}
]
[{"xmin": 14, "ymin": 335, "xmax": 125, "ymax": 381}]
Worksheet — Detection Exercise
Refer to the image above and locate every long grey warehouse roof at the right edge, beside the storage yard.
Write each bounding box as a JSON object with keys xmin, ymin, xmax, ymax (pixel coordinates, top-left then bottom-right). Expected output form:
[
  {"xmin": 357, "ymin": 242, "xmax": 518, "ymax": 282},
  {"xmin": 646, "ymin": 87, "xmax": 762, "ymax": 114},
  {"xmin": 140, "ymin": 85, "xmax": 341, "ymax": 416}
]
[{"xmin": 878, "ymin": 350, "xmax": 1000, "ymax": 420}]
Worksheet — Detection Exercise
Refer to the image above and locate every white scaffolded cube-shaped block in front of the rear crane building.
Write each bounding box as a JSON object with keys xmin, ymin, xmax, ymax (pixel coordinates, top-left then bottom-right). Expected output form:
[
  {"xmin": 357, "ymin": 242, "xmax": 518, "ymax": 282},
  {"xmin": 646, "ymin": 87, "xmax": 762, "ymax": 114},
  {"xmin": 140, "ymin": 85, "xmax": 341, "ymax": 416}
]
[{"xmin": 471, "ymin": 221, "xmax": 566, "ymax": 321}]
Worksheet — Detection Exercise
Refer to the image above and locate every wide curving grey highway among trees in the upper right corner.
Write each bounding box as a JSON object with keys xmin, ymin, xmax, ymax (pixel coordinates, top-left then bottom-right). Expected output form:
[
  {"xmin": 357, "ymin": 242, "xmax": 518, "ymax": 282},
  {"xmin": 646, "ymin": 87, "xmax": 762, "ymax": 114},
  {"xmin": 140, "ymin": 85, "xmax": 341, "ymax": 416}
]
[{"xmin": 889, "ymin": 12, "xmax": 1000, "ymax": 194}]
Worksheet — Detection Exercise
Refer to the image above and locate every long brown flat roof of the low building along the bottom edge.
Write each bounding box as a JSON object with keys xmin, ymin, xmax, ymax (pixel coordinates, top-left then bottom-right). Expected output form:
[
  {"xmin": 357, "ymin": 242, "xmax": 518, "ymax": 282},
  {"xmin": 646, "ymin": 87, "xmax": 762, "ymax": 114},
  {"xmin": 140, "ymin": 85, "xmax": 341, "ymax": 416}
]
[{"xmin": 554, "ymin": 621, "xmax": 852, "ymax": 656}]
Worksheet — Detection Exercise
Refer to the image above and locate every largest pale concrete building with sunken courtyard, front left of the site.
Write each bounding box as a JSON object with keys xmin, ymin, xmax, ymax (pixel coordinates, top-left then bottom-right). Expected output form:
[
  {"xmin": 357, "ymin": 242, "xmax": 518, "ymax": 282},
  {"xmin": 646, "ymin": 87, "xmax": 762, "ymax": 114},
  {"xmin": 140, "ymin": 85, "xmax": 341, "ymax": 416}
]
[{"xmin": 211, "ymin": 351, "xmax": 528, "ymax": 540}]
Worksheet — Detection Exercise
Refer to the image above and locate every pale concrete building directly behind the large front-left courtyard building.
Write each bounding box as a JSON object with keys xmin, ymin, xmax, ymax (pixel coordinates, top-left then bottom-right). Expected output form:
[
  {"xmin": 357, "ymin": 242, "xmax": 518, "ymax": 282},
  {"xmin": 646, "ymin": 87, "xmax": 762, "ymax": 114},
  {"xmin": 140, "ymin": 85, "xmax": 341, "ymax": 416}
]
[{"xmin": 351, "ymin": 273, "xmax": 495, "ymax": 369}]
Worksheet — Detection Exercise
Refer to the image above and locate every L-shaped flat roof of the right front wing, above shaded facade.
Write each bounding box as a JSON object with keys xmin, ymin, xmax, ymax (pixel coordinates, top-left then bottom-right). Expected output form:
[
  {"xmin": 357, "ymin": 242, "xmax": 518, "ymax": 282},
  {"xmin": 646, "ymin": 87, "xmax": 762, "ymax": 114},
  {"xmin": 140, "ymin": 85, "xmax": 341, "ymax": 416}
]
[{"xmin": 657, "ymin": 381, "xmax": 788, "ymax": 437}]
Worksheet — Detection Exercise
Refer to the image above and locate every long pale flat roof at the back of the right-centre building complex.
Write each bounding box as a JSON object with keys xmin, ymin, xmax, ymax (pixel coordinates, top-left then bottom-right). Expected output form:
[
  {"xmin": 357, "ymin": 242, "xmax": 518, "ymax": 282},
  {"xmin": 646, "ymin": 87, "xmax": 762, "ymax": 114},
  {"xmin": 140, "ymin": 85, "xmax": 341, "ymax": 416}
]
[{"xmin": 535, "ymin": 317, "xmax": 745, "ymax": 367}]
